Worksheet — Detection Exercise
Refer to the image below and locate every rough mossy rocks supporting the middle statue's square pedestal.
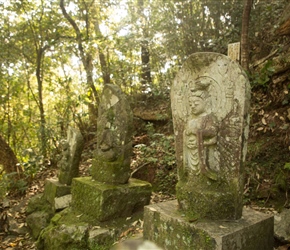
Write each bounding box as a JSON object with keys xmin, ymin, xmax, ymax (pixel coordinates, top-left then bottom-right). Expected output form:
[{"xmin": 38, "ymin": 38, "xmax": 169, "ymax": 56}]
[{"xmin": 36, "ymin": 207, "xmax": 143, "ymax": 250}]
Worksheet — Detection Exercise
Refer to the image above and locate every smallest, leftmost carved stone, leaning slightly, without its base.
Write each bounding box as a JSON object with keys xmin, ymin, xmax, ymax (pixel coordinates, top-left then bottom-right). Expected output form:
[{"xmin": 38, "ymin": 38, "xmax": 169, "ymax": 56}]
[{"xmin": 58, "ymin": 127, "xmax": 84, "ymax": 185}]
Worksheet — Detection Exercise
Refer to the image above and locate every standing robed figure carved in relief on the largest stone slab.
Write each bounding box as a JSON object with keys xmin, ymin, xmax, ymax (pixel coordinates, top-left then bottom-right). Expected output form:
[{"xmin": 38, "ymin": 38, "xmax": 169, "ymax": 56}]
[{"xmin": 183, "ymin": 79, "xmax": 219, "ymax": 179}]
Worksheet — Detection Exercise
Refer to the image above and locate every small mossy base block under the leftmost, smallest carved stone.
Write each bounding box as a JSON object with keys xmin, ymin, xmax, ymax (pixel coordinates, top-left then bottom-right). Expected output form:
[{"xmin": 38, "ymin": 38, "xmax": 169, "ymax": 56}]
[{"xmin": 43, "ymin": 179, "xmax": 71, "ymax": 207}]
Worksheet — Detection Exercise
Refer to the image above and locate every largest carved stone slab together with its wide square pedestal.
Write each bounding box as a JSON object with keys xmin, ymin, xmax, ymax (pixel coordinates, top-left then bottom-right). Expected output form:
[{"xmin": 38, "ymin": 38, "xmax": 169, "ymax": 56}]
[{"xmin": 143, "ymin": 53, "xmax": 273, "ymax": 250}]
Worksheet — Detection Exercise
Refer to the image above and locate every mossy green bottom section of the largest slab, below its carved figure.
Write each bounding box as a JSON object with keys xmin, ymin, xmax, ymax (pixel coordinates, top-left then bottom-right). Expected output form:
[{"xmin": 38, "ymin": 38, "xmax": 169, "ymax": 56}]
[{"xmin": 176, "ymin": 176, "xmax": 243, "ymax": 220}]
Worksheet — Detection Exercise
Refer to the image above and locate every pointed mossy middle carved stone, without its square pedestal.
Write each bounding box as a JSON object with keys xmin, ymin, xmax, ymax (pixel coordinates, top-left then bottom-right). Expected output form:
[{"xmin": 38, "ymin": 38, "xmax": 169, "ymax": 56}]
[{"xmin": 91, "ymin": 84, "xmax": 133, "ymax": 184}]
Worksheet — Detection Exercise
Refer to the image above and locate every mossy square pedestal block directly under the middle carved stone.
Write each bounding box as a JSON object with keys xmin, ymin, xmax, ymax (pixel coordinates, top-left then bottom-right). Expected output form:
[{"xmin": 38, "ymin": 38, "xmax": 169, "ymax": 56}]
[{"xmin": 71, "ymin": 177, "xmax": 151, "ymax": 221}]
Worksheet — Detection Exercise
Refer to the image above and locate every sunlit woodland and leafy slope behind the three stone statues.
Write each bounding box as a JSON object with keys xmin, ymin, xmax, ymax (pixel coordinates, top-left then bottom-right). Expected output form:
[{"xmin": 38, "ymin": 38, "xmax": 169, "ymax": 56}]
[{"xmin": 0, "ymin": 0, "xmax": 290, "ymax": 209}]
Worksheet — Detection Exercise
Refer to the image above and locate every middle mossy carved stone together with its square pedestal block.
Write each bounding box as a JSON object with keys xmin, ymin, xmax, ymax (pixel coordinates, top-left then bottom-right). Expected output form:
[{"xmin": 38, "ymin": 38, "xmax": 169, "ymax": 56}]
[{"xmin": 72, "ymin": 84, "xmax": 151, "ymax": 221}]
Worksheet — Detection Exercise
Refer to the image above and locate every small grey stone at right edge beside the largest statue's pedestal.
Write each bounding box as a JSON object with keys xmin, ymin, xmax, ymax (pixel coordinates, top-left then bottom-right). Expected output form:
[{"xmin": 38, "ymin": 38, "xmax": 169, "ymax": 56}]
[{"xmin": 274, "ymin": 209, "xmax": 290, "ymax": 241}]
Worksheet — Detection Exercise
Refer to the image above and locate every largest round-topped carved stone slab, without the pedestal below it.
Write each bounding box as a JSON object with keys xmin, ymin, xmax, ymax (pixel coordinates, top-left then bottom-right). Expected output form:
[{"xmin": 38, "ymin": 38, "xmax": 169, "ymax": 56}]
[{"xmin": 171, "ymin": 53, "xmax": 250, "ymax": 220}]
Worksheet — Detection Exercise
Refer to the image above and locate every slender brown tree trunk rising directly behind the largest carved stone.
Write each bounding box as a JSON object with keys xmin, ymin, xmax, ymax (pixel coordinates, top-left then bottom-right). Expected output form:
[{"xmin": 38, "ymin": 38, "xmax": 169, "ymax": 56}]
[{"xmin": 241, "ymin": 0, "xmax": 253, "ymax": 71}]
